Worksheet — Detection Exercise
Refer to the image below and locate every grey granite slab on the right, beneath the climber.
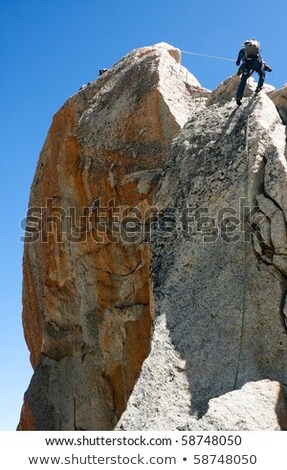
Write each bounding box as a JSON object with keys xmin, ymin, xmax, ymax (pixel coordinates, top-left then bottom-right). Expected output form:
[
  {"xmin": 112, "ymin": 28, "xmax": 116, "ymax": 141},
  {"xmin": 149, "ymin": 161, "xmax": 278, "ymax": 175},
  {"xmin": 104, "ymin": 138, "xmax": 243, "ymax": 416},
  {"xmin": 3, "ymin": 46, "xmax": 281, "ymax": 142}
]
[{"xmin": 118, "ymin": 78, "xmax": 287, "ymax": 430}]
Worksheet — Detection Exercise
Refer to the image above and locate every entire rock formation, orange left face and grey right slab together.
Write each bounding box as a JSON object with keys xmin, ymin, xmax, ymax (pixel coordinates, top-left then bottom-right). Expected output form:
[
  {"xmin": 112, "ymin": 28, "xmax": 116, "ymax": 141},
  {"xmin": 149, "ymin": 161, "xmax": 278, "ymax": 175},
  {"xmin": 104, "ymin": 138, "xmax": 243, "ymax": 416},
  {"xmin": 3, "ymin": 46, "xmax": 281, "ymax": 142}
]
[{"xmin": 18, "ymin": 44, "xmax": 287, "ymax": 430}]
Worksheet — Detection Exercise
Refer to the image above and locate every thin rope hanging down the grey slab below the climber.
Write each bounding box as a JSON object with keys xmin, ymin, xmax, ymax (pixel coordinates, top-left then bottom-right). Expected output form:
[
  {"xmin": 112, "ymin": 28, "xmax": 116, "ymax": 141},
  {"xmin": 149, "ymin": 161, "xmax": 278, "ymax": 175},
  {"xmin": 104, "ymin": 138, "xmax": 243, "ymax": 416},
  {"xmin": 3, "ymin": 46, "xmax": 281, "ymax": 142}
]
[{"xmin": 233, "ymin": 106, "xmax": 251, "ymax": 390}]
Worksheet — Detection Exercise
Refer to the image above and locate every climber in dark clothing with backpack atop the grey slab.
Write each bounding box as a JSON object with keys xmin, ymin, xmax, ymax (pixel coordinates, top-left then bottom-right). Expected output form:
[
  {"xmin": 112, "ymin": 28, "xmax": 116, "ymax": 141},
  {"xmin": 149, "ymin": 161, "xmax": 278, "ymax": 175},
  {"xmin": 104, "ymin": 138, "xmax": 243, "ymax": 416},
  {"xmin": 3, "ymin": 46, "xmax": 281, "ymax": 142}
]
[{"xmin": 236, "ymin": 39, "xmax": 272, "ymax": 106}]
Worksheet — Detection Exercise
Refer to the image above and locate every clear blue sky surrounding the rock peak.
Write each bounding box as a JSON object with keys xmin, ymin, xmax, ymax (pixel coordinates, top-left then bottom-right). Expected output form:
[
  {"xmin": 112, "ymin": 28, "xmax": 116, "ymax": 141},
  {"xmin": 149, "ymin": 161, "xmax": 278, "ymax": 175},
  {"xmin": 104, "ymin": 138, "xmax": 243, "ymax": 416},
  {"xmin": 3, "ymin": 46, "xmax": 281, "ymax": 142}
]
[{"xmin": 0, "ymin": 0, "xmax": 287, "ymax": 430}]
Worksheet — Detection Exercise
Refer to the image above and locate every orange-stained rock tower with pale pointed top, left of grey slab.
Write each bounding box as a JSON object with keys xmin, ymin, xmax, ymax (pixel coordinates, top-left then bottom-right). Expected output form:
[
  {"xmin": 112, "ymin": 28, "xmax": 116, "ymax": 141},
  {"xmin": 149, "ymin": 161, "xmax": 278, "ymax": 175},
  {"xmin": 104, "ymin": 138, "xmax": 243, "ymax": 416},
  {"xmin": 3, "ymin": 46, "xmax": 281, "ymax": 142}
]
[{"xmin": 19, "ymin": 44, "xmax": 207, "ymax": 430}]
